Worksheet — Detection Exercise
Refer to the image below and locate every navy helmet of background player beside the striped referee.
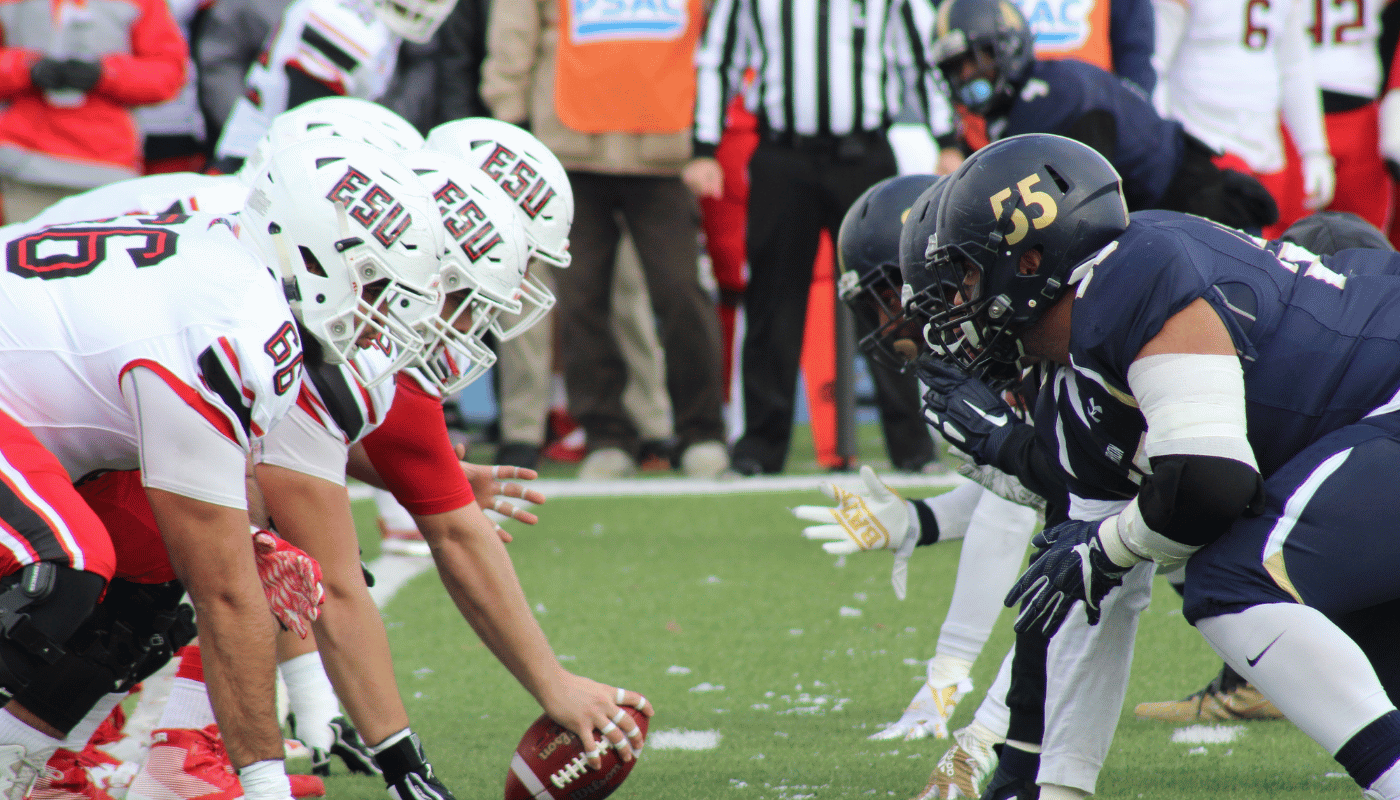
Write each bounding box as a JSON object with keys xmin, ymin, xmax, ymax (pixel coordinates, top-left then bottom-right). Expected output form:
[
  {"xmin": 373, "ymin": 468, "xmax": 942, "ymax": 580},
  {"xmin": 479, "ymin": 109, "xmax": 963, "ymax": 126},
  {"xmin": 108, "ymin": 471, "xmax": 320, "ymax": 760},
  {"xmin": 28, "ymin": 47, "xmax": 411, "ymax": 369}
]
[{"xmin": 930, "ymin": 0, "xmax": 1036, "ymax": 116}]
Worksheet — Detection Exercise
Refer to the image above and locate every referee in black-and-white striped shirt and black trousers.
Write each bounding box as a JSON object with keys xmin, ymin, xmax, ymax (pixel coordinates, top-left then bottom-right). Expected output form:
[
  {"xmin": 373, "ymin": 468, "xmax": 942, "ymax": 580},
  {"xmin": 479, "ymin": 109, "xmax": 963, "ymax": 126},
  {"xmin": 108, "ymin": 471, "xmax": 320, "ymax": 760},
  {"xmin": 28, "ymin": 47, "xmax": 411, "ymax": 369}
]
[{"xmin": 685, "ymin": 0, "xmax": 949, "ymax": 475}]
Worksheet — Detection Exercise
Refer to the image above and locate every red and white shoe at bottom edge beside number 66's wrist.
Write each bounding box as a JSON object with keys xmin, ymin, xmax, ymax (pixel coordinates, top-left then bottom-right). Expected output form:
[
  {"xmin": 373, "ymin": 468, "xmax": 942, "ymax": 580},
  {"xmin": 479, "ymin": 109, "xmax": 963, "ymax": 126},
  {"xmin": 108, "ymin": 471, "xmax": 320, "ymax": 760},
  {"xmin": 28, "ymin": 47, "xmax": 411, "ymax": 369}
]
[{"xmin": 126, "ymin": 726, "xmax": 326, "ymax": 800}]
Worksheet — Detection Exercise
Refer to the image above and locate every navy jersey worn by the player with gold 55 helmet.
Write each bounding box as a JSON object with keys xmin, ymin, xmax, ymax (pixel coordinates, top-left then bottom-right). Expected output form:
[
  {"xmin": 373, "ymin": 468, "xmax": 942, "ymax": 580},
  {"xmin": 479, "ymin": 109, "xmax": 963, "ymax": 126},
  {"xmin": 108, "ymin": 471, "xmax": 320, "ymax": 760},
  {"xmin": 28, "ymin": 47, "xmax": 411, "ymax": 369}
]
[{"xmin": 1037, "ymin": 205, "xmax": 1400, "ymax": 484}]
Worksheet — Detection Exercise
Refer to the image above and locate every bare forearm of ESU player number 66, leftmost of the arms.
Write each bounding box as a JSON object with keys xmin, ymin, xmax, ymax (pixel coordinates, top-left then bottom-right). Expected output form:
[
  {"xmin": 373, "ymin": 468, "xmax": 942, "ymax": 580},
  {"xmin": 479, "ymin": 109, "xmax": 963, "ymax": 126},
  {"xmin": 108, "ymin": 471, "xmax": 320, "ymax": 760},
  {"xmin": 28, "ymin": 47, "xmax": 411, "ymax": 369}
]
[{"xmin": 147, "ymin": 489, "xmax": 283, "ymax": 768}]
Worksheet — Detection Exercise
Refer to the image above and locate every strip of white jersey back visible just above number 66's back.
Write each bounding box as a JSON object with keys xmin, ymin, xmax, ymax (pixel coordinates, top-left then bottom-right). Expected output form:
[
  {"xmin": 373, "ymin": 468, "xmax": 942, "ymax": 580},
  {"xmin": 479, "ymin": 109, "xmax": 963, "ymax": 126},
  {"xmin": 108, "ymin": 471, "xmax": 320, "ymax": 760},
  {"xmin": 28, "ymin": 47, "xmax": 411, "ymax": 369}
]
[{"xmin": 24, "ymin": 172, "xmax": 248, "ymax": 228}]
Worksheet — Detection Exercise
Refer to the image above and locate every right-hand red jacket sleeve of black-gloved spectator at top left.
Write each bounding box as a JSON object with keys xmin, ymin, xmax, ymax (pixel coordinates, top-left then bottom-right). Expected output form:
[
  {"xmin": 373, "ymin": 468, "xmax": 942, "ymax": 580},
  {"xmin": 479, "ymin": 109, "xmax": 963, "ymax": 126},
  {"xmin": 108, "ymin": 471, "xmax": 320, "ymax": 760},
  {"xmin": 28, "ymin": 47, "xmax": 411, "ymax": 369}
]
[{"xmin": 92, "ymin": 0, "xmax": 189, "ymax": 105}]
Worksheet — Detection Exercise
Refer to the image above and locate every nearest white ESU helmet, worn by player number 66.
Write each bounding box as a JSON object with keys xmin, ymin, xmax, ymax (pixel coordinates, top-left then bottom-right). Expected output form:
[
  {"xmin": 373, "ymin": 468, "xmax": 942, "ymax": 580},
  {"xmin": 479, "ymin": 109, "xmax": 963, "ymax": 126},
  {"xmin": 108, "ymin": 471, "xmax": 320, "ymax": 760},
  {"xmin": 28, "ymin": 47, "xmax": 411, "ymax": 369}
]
[{"xmin": 239, "ymin": 139, "xmax": 444, "ymax": 387}]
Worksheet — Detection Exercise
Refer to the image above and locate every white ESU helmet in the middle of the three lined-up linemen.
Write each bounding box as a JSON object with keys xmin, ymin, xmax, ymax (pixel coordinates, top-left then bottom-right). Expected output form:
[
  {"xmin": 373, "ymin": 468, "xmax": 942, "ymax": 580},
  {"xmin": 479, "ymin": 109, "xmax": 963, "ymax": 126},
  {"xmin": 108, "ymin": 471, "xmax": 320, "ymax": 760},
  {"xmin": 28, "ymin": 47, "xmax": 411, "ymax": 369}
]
[{"xmin": 399, "ymin": 150, "xmax": 529, "ymax": 396}]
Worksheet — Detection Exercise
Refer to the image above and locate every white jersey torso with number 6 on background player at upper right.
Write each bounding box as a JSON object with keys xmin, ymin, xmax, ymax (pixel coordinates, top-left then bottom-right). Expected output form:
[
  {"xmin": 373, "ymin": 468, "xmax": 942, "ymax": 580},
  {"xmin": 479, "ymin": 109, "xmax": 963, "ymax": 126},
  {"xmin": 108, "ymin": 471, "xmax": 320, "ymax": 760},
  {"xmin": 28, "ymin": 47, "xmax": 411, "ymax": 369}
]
[{"xmin": 1158, "ymin": 0, "xmax": 1298, "ymax": 172}]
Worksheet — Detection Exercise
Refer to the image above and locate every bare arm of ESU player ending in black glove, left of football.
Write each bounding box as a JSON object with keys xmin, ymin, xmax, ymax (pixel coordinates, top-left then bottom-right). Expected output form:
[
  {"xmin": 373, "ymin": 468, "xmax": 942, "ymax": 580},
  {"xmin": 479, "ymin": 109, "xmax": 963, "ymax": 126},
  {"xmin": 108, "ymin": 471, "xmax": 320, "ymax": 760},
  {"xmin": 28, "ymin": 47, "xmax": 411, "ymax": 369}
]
[{"xmin": 256, "ymin": 464, "xmax": 409, "ymax": 744}]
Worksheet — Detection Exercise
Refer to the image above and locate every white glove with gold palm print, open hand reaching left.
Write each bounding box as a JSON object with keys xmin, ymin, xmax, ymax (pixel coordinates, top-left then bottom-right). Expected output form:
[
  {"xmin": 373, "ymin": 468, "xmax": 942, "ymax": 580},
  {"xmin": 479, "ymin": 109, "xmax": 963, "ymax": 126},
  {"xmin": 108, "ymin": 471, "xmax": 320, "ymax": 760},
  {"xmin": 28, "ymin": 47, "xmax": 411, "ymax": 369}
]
[{"xmin": 792, "ymin": 465, "xmax": 920, "ymax": 600}]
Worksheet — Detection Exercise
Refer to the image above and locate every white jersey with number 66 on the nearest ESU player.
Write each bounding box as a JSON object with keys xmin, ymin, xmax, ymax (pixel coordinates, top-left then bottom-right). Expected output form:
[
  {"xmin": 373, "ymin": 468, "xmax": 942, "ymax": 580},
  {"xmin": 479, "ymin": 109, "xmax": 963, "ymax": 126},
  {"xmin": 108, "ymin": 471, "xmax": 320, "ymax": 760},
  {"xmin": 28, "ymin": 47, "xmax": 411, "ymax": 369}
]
[{"xmin": 0, "ymin": 214, "xmax": 302, "ymax": 479}]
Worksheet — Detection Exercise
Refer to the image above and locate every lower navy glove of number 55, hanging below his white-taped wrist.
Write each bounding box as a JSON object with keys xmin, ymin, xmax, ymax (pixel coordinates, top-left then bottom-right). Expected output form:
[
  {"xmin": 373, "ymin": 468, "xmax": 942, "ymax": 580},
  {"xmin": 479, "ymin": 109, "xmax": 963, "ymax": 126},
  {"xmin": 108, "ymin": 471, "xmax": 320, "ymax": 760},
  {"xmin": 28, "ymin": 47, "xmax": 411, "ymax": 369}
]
[{"xmin": 1007, "ymin": 520, "xmax": 1128, "ymax": 636}]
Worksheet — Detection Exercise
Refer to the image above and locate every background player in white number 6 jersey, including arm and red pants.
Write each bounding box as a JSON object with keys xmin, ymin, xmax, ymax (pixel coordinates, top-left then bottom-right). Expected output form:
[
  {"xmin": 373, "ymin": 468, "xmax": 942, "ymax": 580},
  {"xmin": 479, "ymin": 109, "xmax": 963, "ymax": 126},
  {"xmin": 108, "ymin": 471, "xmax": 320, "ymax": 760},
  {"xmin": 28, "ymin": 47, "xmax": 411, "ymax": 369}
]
[{"xmin": 1152, "ymin": 0, "xmax": 1338, "ymax": 238}]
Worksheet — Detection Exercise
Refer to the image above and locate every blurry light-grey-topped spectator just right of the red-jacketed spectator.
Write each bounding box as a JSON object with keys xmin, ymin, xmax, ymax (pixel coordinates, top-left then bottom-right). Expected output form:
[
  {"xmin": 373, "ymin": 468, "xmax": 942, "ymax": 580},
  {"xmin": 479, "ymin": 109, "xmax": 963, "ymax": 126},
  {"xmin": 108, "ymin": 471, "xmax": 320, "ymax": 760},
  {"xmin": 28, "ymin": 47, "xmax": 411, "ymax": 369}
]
[{"xmin": 136, "ymin": 0, "xmax": 213, "ymax": 175}]
